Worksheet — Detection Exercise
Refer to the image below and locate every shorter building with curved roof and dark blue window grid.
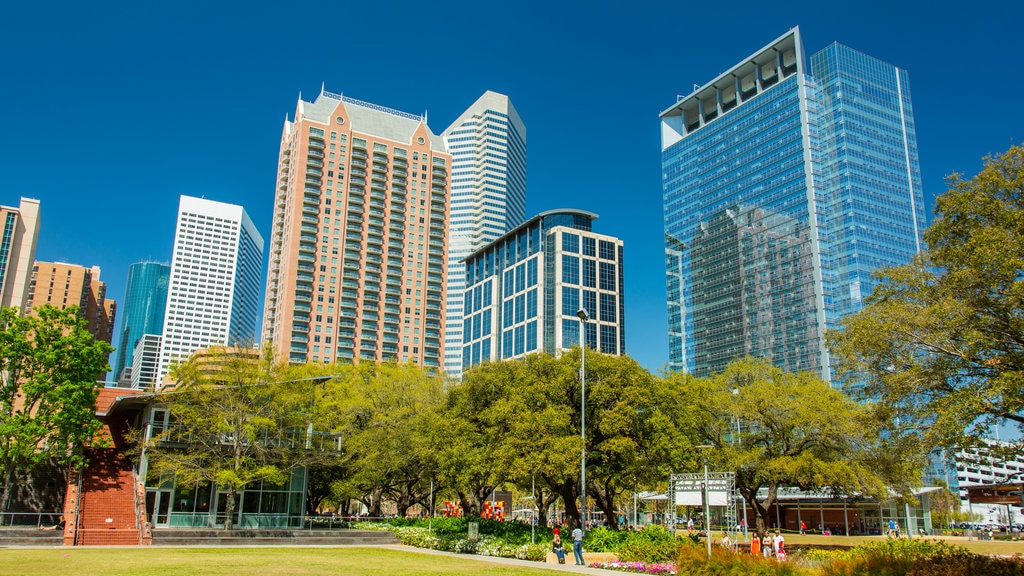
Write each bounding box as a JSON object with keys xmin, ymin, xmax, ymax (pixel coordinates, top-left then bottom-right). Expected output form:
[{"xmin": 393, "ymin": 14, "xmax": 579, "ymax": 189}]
[{"xmin": 462, "ymin": 210, "xmax": 626, "ymax": 368}]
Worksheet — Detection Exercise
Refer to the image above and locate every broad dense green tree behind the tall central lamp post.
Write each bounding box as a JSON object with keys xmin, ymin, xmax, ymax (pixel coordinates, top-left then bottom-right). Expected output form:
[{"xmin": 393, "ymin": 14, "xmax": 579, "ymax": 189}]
[{"xmin": 448, "ymin": 347, "xmax": 686, "ymax": 526}]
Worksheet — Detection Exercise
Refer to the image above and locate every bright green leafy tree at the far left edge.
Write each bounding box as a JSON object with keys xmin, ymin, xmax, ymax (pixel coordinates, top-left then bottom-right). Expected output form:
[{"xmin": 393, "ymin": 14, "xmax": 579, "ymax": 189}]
[{"xmin": 0, "ymin": 305, "xmax": 114, "ymax": 510}]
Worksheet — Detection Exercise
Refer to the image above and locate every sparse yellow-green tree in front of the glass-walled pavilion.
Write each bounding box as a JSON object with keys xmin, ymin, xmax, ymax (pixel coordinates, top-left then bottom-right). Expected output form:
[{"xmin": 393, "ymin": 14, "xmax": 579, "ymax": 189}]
[{"xmin": 146, "ymin": 342, "xmax": 309, "ymax": 530}]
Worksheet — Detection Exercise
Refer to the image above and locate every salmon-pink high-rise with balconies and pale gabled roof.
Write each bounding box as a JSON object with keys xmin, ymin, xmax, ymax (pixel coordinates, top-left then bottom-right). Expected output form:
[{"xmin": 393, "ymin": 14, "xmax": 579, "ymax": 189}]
[{"xmin": 263, "ymin": 91, "xmax": 452, "ymax": 369}]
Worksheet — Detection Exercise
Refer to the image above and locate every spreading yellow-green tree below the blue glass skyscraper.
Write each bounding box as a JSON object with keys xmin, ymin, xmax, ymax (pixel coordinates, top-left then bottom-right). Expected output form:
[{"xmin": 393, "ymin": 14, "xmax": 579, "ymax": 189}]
[{"xmin": 668, "ymin": 358, "xmax": 924, "ymax": 534}]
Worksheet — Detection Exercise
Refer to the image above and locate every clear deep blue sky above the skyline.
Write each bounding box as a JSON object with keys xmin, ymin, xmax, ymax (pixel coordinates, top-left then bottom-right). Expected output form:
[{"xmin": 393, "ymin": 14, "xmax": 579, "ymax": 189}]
[{"xmin": 0, "ymin": 0, "xmax": 1024, "ymax": 371}]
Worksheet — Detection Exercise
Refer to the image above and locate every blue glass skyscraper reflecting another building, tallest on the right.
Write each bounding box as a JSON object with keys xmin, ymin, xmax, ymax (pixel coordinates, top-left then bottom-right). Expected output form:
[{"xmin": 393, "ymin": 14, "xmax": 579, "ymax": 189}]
[{"xmin": 660, "ymin": 29, "xmax": 924, "ymax": 380}]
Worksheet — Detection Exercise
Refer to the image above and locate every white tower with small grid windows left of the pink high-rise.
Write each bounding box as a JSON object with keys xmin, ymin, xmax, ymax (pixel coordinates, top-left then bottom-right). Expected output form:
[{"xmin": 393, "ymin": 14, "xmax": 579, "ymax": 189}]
[{"xmin": 158, "ymin": 196, "xmax": 263, "ymax": 382}]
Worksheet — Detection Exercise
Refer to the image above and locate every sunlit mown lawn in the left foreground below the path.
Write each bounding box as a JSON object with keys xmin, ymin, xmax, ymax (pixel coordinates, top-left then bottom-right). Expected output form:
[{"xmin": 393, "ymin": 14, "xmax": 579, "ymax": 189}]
[{"xmin": 0, "ymin": 547, "xmax": 551, "ymax": 576}]
